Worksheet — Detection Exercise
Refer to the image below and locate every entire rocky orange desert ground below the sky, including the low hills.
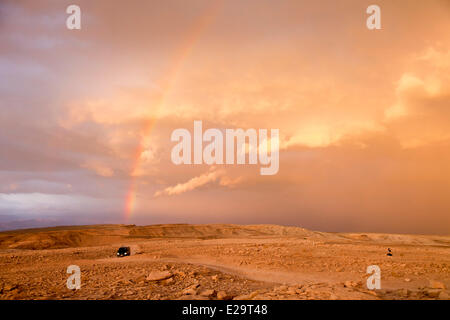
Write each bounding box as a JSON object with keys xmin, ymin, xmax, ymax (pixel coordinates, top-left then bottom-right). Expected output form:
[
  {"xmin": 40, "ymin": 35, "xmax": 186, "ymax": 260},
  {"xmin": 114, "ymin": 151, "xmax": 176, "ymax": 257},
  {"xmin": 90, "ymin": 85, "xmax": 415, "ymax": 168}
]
[{"xmin": 0, "ymin": 224, "xmax": 450, "ymax": 300}]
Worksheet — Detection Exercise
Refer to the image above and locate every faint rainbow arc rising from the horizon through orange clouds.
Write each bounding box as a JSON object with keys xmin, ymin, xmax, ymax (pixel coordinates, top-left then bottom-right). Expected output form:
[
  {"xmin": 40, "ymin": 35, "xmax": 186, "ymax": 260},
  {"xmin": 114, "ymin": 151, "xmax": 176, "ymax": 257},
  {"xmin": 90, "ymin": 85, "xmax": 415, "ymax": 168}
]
[{"xmin": 124, "ymin": 0, "xmax": 224, "ymax": 222}]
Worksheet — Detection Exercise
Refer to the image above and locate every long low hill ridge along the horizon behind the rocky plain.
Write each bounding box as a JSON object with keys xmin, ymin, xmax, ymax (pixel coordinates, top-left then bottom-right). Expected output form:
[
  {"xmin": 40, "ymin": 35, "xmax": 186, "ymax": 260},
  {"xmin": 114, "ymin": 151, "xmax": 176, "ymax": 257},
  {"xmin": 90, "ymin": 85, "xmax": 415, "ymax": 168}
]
[{"xmin": 0, "ymin": 224, "xmax": 450, "ymax": 250}]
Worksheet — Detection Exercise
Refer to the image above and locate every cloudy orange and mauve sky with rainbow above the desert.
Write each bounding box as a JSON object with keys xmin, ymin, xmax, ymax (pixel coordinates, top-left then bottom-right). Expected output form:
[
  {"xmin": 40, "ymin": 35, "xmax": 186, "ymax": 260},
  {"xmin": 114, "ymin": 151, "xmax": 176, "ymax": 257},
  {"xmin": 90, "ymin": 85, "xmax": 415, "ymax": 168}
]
[{"xmin": 0, "ymin": 0, "xmax": 450, "ymax": 234}]
